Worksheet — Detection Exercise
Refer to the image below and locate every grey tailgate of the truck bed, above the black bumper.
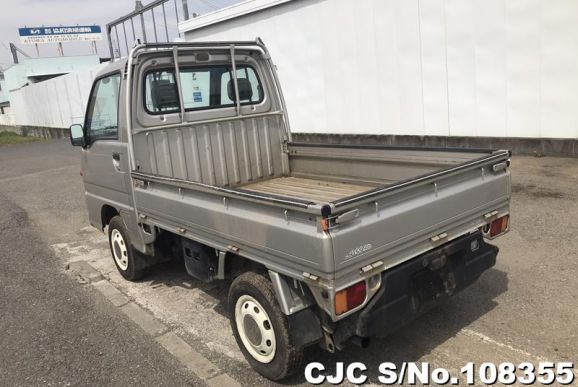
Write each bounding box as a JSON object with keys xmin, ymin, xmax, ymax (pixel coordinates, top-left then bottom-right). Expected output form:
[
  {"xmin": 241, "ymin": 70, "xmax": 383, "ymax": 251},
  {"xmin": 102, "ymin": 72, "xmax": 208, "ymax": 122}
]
[{"xmin": 330, "ymin": 151, "xmax": 510, "ymax": 284}]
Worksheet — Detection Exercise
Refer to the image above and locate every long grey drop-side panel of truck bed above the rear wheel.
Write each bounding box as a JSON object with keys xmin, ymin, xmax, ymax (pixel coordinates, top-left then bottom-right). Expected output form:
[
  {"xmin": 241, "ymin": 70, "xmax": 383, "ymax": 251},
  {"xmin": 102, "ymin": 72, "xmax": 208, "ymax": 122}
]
[{"xmin": 134, "ymin": 181, "xmax": 334, "ymax": 277}]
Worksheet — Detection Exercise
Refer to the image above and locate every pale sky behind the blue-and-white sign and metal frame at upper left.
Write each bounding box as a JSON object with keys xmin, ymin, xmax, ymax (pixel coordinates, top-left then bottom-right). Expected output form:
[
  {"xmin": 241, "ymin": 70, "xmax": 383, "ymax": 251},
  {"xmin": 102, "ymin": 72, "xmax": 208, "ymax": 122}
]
[{"xmin": 0, "ymin": 0, "xmax": 239, "ymax": 69}]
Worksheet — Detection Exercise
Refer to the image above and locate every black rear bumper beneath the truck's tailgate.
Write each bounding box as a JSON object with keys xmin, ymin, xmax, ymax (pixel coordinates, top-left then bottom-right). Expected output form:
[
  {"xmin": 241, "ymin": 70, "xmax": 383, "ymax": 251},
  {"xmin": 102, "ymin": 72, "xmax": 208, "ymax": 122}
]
[{"xmin": 334, "ymin": 232, "xmax": 498, "ymax": 346}]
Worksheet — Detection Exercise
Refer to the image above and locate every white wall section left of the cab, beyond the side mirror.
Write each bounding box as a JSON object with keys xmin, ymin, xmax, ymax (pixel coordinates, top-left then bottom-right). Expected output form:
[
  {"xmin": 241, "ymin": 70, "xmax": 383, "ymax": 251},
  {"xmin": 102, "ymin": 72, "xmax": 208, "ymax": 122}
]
[{"xmin": 10, "ymin": 64, "xmax": 105, "ymax": 128}]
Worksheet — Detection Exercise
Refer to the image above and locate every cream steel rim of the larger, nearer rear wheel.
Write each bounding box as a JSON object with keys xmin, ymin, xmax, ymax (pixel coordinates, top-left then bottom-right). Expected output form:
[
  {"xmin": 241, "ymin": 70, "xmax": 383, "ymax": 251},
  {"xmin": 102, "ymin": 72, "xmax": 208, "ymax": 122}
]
[{"xmin": 235, "ymin": 295, "xmax": 277, "ymax": 364}]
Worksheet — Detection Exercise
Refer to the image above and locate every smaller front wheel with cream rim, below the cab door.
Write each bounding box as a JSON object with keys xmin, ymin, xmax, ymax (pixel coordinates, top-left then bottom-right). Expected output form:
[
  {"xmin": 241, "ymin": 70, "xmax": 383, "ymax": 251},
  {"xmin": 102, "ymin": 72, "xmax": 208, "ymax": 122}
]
[{"xmin": 108, "ymin": 215, "xmax": 146, "ymax": 281}]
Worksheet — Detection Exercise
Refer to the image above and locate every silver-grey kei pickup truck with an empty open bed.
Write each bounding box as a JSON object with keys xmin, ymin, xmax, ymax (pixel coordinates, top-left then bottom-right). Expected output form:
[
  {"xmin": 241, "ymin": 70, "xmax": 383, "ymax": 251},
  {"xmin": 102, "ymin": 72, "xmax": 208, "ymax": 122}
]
[{"xmin": 70, "ymin": 39, "xmax": 510, "ymax": 380}]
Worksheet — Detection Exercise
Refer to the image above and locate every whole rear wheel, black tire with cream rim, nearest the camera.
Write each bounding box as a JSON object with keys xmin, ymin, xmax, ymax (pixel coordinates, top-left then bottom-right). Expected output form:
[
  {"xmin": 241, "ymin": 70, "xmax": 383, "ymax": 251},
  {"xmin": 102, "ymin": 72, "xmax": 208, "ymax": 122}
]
[{"xmin": 228, "ymin": 272, "xmax": 303, "ymax": 380}]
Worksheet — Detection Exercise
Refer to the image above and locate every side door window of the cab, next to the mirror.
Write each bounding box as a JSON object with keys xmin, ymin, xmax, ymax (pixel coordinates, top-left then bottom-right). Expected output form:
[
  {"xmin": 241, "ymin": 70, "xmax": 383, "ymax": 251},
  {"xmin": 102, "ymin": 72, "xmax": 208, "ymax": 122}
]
[{"xmin": 86, "ymin": 74, "xmax": 120, "ymax": 141}]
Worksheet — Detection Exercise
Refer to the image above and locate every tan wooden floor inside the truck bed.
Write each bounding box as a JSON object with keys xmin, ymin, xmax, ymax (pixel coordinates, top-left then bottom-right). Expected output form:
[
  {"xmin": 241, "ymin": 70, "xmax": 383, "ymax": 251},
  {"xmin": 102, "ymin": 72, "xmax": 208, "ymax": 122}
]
[{"xmin": 241, "ymin": 177, "xmax": 371, "ymax": 202}]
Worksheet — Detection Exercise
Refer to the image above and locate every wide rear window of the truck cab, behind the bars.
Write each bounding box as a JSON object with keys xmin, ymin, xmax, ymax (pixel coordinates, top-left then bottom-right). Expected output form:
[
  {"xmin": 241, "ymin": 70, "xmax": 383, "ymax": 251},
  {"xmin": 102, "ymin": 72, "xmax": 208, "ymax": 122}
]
[{"xmin": 144, "ymin": 65, "xmax": 263, "ymax": 114}]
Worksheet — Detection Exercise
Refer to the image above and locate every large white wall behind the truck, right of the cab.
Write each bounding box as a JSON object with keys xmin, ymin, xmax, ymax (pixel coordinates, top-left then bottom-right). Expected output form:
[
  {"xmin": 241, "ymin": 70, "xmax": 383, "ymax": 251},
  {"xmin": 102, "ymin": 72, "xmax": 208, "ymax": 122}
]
[{"xmin": 180, "ymin": 0, "xmax": 578, "ymax": 138}]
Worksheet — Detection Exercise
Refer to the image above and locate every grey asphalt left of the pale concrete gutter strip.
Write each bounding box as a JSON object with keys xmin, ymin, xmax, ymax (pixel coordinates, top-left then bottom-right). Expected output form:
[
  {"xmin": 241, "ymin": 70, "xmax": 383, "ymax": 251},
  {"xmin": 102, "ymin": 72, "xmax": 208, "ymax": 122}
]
[{"xmin": 0, "ymin": 142, "xmax": 202, "ymax": 386}]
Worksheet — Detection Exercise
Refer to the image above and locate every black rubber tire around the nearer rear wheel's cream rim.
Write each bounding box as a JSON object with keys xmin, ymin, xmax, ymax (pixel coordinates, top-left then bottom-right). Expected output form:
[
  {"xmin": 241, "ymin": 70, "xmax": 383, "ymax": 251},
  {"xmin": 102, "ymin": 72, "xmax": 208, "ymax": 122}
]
[{"xmin": 228, "ymin": 272, "xmax": 303, "ymax": 381}]
